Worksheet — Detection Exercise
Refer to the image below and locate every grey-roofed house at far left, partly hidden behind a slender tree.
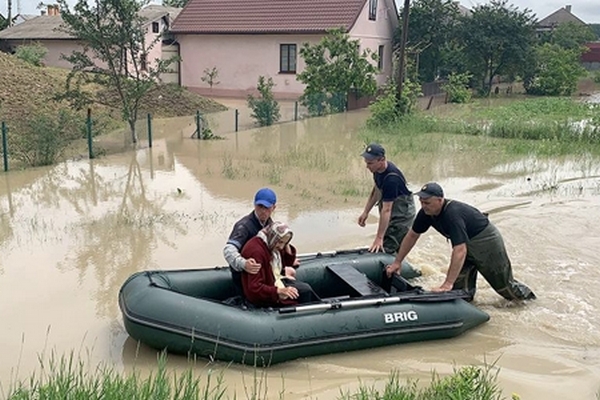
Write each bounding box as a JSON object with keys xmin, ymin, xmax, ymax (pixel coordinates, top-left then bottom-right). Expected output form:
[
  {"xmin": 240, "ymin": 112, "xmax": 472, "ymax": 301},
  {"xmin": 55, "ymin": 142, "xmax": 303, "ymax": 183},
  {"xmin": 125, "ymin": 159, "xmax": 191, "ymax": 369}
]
[{"xmin": 0, "ymin": 5, "xmax": 181, "ymax": 83}]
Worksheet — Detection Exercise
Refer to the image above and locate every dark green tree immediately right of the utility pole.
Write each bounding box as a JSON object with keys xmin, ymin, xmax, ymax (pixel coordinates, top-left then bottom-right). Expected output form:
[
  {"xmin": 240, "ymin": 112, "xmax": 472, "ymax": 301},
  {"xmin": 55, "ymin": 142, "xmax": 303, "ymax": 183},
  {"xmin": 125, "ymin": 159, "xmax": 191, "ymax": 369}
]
[{"xmin": 395, "ymin": 0, "xmax": 459, "ymax": 82}]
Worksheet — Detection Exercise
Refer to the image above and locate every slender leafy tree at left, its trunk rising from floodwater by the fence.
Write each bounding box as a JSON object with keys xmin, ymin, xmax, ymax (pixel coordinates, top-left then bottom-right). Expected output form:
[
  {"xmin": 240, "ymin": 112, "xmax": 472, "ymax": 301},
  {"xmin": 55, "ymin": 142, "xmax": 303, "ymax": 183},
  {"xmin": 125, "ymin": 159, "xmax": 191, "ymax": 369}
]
[{"xmin": 58, "ymin": 0, "xmax": 175, "ymax": 143}]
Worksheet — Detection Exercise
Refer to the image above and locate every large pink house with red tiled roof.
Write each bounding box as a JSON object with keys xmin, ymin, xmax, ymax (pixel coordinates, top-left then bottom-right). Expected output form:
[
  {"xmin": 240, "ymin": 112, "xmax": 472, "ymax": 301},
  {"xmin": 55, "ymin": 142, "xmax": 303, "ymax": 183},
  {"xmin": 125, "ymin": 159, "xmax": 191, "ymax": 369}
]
[{"xmin": 171, "ymin": 0, "xmax": 398, "ymax": 99}]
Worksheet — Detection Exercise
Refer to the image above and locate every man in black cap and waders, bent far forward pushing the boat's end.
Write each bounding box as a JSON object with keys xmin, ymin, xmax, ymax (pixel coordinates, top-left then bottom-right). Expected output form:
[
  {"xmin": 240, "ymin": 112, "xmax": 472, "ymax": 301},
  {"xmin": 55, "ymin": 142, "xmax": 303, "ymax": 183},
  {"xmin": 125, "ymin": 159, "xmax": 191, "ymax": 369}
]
[{"xmin": 386, "ymin": 182, "xmax": 535, "ymax": 300}]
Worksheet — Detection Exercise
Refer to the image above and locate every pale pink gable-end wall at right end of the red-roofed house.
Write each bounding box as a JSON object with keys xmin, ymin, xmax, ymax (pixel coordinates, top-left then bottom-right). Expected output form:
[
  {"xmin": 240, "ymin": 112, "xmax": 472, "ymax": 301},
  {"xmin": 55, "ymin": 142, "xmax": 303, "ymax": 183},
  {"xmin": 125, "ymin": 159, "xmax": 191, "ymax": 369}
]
[{"xmin": 349, "ymin": 0, "xmax": 398, "ymax": 85}]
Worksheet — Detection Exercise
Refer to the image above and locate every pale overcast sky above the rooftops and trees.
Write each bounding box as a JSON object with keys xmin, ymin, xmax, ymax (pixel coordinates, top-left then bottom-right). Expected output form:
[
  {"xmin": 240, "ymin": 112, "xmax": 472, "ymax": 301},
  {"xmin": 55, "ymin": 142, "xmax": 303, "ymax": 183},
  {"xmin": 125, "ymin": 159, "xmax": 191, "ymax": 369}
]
[{"xmin": 0, "ymin": 0, "xmax": 600, "ymax": 24}]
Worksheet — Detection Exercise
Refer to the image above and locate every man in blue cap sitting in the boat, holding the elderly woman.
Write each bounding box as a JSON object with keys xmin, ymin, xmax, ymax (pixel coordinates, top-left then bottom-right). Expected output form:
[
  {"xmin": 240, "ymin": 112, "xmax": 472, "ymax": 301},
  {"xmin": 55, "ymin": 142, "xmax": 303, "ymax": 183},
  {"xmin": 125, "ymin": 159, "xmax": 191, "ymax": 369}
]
[{"xmin": 223, "ymin": 188, "xmax": 277, "ymax": 294}]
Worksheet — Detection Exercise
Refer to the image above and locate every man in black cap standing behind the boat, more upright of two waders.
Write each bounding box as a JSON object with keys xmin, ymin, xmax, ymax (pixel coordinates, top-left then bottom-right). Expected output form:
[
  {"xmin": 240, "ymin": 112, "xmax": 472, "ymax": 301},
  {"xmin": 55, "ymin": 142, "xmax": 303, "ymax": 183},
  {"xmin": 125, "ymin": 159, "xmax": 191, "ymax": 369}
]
[{"xmin": 358, "ymin": 143, "xmax": 415, "ymax": 253}]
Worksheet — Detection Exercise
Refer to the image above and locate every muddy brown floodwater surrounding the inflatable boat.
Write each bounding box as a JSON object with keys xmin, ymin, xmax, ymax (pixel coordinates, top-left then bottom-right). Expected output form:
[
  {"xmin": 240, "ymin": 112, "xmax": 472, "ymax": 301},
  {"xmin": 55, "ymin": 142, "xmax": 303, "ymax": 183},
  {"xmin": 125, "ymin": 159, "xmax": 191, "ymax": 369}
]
[{"xmin": 0, "ymin": 107, "xmax": 600, "ymax": 400}]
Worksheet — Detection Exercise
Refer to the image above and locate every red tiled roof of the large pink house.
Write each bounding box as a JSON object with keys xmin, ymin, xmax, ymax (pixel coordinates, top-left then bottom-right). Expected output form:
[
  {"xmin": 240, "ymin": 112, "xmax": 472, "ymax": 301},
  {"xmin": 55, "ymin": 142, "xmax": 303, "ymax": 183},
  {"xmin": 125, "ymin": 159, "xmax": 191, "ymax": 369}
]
[{"xmin": 171, "ymin": 0, "xmax": 367, "ymax": 33}]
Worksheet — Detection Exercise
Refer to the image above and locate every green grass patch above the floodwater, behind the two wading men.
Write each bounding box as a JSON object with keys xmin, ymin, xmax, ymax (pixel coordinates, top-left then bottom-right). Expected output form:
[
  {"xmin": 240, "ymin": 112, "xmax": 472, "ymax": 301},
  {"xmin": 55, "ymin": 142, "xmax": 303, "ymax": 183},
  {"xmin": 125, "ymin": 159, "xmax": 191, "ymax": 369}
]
[{"xmin": 361, "ymin": 98, "xmax": 600, "ymax": 156}]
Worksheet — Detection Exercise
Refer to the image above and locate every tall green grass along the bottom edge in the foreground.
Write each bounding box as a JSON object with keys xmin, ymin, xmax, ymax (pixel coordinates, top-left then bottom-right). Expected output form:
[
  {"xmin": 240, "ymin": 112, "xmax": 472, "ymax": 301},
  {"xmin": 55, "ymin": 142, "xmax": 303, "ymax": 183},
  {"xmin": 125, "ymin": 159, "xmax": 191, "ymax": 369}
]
[{"xmin": 0, "ymin": 354, "xmax": 519, "ymax": 400}]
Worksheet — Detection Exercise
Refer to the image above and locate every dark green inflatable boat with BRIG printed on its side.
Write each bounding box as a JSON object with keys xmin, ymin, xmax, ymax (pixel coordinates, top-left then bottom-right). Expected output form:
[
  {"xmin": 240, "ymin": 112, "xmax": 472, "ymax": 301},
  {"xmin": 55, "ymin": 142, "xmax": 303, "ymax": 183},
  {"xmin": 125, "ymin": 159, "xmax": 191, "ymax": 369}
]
[{"xmin": 119, "ymin": 249, "xmax": 489, "ymax": 366}]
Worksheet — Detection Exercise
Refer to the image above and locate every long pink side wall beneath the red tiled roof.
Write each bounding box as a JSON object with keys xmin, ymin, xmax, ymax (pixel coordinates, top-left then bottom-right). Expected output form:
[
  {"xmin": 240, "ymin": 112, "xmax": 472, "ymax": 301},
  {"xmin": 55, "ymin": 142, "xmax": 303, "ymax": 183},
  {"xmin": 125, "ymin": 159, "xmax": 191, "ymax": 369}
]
[{"xmin": 177, "ymin": 35, "xmax": 322, "ymax": 99}]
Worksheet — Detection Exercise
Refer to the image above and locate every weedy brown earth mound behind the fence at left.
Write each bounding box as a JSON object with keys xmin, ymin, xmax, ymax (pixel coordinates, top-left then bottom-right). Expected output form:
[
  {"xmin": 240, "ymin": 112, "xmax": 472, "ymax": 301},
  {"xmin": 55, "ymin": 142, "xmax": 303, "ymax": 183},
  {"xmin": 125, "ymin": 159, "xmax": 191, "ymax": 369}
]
[{"xmin": 0, "ymin": 53, "xmax": 225, "ymax": 169}]
